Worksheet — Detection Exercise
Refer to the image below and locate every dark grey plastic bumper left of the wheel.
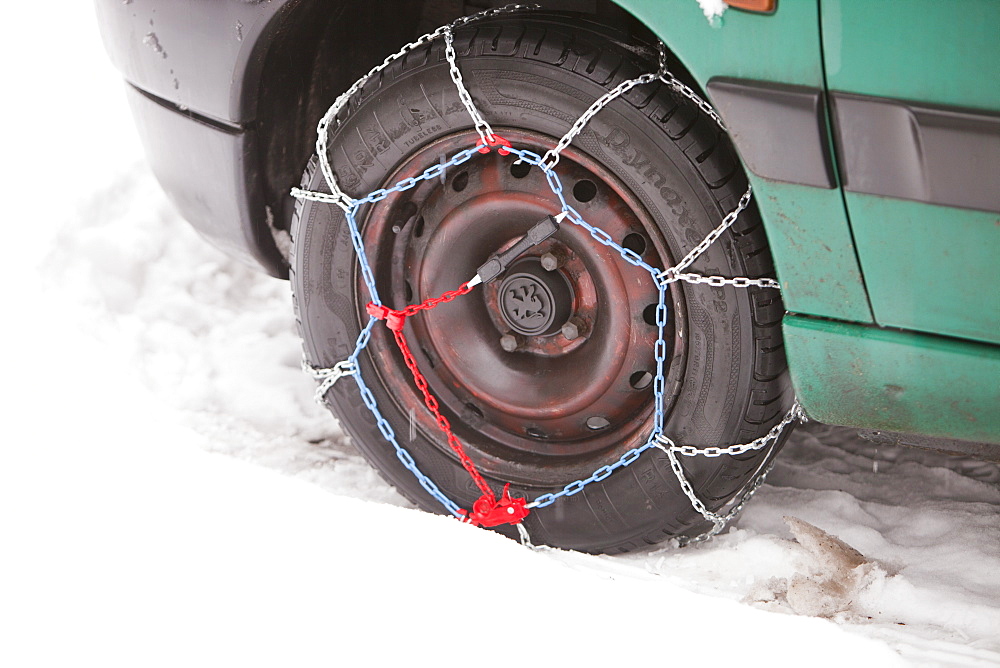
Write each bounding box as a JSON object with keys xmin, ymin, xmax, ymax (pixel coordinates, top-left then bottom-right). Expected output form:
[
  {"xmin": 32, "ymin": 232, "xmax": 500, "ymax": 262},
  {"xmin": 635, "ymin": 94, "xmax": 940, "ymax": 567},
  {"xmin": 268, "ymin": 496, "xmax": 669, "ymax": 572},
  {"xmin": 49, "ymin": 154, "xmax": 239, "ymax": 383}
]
[{"xmin": 95, "ymin": 0, "xmax": 299, "ymax": 276}]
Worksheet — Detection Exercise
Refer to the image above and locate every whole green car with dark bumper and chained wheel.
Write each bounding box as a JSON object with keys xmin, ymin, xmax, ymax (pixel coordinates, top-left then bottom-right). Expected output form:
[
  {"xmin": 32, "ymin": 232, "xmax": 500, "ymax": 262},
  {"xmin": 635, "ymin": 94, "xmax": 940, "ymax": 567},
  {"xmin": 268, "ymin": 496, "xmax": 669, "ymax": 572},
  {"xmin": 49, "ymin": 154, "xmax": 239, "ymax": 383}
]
[{"xmin": 96, "ymin": 0, "xmax": 1000, "ymax": 553}]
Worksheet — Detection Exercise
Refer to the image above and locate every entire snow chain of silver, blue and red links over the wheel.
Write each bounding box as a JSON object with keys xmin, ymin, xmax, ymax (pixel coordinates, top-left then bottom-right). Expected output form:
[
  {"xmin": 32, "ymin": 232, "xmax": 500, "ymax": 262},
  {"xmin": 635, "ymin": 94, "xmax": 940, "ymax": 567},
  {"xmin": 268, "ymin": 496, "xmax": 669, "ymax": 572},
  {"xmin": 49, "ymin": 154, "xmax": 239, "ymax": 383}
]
[{"xmin": 291, "ymin": 5, "xmax": 806, "ymax": 547}]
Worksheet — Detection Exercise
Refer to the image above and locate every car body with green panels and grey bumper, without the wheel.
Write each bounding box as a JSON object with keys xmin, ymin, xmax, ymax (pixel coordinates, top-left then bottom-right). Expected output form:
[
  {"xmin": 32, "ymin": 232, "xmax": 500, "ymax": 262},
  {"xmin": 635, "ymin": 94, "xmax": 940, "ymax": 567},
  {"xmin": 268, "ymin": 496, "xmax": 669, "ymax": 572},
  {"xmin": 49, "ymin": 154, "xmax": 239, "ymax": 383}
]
[{"xmin": 95, "ymin": 0, "xmax": 1000, "ymax": 448}]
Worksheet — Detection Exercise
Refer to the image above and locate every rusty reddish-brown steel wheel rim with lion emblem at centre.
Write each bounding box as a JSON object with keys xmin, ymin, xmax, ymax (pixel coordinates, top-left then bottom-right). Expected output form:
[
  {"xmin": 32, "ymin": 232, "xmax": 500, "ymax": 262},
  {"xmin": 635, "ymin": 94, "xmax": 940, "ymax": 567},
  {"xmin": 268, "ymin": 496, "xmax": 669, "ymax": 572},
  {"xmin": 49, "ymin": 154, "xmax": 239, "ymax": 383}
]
[{"xmin": 355, "ymin": 129, "xmax": 683, "ymax": 484}]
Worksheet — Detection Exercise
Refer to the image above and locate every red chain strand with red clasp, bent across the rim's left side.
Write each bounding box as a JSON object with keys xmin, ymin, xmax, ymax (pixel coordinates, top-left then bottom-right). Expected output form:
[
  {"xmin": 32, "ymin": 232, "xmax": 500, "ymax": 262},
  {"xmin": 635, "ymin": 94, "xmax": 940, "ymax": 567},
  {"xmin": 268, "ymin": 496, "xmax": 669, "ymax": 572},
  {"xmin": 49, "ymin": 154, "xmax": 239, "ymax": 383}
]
[{"xmin": 365, "ymin": 283, "xmax": 529, "ymax": 527}]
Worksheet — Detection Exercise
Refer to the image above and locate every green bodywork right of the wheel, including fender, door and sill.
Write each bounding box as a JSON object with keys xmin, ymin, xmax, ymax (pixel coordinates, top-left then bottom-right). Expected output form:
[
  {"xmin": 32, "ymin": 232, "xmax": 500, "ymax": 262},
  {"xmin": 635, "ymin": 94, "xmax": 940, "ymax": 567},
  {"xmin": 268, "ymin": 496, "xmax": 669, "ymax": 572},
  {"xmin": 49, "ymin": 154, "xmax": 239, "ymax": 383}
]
[{"xmin": 621, "ymin": 0, "xmax": 1000, "ymax": 443}]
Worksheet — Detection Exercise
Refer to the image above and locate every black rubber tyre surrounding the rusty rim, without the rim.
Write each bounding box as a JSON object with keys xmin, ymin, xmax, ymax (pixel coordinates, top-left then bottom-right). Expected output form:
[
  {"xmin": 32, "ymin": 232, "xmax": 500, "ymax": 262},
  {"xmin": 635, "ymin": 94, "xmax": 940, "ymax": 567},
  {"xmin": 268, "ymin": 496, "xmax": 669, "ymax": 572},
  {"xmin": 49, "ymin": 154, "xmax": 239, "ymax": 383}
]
[{"xmin": 291, "ymin": 14, "xmax": 792, "ymax": 552}]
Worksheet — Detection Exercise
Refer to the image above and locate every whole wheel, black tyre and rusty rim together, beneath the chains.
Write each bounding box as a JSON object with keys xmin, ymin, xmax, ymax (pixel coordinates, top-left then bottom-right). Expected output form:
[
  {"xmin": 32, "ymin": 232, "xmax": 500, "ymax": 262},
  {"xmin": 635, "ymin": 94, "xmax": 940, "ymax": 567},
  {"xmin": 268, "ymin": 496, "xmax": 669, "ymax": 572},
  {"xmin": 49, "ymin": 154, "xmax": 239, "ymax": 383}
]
[{"xmin": 291, "ymin": 14, "xmax": 792, "ymax": 553}]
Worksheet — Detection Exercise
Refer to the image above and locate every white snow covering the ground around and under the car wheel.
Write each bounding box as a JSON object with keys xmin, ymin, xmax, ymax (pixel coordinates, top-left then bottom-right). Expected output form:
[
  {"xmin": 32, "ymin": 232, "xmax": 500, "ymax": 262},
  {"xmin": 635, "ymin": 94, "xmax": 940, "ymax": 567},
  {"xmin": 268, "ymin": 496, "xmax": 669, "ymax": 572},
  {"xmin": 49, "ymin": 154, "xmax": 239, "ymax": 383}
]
[{"xmin": 0, "ymin": 3, "xmax": 1000, "ymax": 666}]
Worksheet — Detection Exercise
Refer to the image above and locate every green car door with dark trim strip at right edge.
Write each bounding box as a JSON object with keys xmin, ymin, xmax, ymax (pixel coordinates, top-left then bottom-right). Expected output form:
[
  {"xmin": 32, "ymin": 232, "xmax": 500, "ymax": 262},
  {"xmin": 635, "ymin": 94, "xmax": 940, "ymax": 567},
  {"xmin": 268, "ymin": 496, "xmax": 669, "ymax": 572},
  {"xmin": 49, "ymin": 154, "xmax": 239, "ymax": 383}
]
[{"xmin": 820, "ymin": 0, "xmax": 1000, "ymax": 343}]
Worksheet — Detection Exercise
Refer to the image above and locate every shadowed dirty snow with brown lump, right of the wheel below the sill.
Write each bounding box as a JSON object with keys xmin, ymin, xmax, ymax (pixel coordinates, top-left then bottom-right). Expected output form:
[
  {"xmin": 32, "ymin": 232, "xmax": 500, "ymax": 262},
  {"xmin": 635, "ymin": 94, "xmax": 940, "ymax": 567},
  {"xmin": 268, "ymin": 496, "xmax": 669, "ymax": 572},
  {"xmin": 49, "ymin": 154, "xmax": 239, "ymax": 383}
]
[{"xmin": 634, "ymin": 424, "xmax": 1000, "ymax": 665}]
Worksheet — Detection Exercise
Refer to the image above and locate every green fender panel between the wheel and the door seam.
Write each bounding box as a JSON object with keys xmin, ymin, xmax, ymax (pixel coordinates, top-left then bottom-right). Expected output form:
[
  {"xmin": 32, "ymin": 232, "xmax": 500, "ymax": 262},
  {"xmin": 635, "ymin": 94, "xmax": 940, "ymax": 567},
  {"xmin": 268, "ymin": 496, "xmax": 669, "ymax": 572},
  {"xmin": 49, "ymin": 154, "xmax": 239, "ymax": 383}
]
[{"xmin": 621, "ymin": 0, "xmax": 873, "ymax": 323}]
